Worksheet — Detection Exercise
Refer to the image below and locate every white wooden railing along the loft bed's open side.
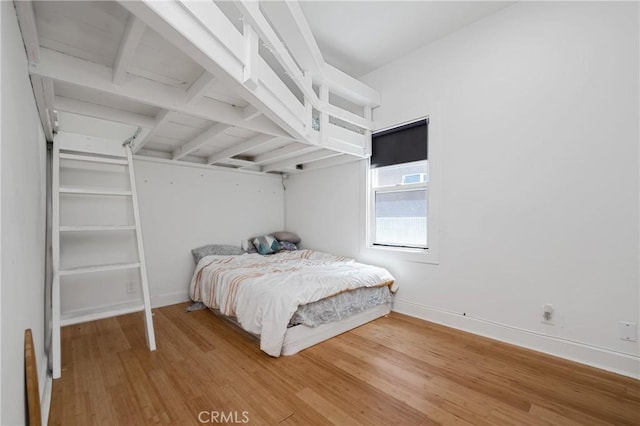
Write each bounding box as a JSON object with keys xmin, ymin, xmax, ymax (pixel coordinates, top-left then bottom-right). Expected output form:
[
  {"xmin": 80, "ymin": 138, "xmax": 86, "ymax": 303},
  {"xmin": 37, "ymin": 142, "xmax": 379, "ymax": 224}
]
[{"xmin": 121, "ymin": 0, "xmax": 380, "ymax": 159}]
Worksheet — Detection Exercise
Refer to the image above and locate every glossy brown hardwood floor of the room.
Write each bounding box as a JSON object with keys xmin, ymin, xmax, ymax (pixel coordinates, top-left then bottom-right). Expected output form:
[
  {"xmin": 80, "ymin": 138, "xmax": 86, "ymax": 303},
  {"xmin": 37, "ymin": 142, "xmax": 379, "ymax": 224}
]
[{"xmin": 49, "ymin": 304, "xmax": 640, "ymax": 425}]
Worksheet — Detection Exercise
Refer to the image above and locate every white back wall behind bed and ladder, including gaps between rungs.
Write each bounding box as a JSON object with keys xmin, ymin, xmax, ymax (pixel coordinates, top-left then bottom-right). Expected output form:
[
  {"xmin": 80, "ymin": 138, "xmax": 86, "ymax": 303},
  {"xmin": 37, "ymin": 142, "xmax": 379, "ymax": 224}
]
[{"xmin": 60, "ymin": 158, "xmax": 284, "ymax": 313}]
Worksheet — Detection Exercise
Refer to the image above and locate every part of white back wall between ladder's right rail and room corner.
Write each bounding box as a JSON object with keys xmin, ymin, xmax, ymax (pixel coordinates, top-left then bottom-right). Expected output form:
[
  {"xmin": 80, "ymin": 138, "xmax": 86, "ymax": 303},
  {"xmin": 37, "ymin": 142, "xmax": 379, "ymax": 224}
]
[{"xmin": 135, "ymin": 159, "xmax": 284, "ymax": 306}]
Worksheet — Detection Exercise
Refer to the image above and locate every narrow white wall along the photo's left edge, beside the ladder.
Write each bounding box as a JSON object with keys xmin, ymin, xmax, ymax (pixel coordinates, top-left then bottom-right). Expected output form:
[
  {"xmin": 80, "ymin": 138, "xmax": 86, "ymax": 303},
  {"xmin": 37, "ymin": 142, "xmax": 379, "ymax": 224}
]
[{"xmin": 0, "ymin": 1, "xmax": 47, "ymax": 425}]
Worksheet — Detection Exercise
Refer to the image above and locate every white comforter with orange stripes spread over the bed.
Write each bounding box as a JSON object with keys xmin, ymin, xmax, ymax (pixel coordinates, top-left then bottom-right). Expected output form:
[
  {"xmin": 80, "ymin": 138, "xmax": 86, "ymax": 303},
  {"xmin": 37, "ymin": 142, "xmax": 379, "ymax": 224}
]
[{"xmin": 189, "ymin": 250, "xmax": 396, "ymax": 357}]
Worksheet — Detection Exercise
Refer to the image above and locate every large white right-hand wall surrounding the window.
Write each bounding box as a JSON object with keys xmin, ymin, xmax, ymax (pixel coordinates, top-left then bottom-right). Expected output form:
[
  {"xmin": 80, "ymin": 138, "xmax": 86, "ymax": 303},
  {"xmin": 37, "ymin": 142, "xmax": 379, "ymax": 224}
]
[{"xmin": 286, "ymin": 2, "xmax": 640, "ymax": 376}]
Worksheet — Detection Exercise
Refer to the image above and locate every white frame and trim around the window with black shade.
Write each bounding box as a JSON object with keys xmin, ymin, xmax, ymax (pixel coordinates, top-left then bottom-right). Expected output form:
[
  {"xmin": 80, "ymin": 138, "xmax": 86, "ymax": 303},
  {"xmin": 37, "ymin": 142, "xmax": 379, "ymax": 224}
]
[{"xmin": 360, "ymin": 114, "xmax": 441, "ymax": 265}]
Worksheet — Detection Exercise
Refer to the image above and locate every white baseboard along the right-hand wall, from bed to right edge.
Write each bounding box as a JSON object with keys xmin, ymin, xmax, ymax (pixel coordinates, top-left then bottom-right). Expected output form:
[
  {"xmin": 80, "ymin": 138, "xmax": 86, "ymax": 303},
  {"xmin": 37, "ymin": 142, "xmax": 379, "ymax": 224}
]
[{"xmin": 392, "ymin": 300, "xmax": 640, "ymax": 379}]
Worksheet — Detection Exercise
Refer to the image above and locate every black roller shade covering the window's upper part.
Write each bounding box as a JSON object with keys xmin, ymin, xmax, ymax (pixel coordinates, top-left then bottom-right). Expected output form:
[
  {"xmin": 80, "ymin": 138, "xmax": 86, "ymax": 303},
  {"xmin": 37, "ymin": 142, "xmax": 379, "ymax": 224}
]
[{"xmin": 371, "ymin": 119, "xmax": 429, "ymax": 169}]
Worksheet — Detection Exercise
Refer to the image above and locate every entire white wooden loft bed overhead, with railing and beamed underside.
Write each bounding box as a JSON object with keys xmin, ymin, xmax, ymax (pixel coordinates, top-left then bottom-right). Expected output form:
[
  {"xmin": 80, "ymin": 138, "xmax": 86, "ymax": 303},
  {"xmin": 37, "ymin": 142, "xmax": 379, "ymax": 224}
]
[{"xmin": 15, "ymin": 0, "xmax": 380, "ymax": 173}]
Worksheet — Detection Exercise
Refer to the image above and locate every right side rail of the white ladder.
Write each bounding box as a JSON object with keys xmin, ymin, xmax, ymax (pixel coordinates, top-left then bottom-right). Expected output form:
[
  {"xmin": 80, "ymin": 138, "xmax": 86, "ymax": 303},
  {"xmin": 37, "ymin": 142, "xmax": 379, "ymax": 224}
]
[{"xmin": 125, "ymin": 142, "xmax": 156, "ymax": 351}]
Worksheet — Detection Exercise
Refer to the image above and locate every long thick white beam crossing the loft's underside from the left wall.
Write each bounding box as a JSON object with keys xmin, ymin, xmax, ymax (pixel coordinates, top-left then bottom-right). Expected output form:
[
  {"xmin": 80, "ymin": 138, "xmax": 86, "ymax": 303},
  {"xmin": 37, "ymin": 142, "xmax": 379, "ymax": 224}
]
[{"xmin": 29, "ymin": 48, "xmax": 290, "ymax": 138}]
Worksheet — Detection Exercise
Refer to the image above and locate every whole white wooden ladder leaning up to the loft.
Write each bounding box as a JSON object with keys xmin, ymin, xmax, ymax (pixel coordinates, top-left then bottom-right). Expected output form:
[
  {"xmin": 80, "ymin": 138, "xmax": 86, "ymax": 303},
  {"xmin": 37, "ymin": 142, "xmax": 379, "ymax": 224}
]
[{"xmin": 51, "ymin": 132, "xmax": 156, "ymax": 379}]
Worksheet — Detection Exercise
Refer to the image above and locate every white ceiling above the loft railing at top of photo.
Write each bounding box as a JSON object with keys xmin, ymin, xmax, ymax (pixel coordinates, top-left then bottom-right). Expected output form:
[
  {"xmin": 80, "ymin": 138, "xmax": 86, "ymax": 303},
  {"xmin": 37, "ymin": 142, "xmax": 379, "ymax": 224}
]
[{"xmin": 300, "ymin": 1, "xmax": 514, "ymax": 77}]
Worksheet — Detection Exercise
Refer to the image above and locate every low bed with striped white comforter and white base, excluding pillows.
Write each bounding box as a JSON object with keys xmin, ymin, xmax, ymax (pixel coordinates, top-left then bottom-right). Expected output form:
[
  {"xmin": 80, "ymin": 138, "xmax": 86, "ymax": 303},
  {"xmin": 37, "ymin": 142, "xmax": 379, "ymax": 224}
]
[{"xmin": 189, "ymin": 250, "xmax": 397, "ymax": 357}]
